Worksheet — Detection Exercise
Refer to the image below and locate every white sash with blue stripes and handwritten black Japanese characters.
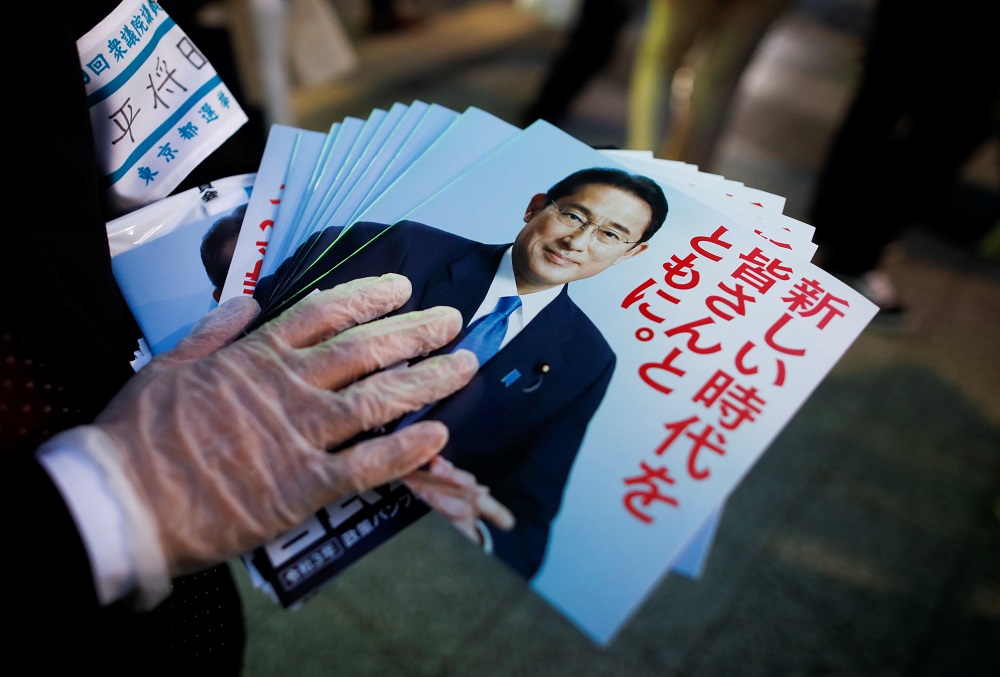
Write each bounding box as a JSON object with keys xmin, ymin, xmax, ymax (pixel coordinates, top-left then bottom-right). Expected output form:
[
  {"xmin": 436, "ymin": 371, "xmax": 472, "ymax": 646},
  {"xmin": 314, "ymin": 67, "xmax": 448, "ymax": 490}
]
[{"xmin": 77, "ymin": 0, "xmax": 247, "ymax": 213}]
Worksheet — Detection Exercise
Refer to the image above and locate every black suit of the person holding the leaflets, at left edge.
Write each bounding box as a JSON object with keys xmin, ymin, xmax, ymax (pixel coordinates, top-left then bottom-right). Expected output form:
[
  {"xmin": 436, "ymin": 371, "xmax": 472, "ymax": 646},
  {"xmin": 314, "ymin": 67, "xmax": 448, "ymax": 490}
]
[{"xmin": 0, "ymin": 0, "xmax": 259, "ymax": 675}]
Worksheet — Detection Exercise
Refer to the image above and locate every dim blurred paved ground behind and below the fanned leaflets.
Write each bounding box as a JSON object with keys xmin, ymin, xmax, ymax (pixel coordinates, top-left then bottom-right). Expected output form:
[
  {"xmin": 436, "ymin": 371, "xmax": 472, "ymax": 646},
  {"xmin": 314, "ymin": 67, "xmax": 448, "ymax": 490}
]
[{"xmin": 229, "ymin": 0, "xmax": 1000, "ymax": 677}]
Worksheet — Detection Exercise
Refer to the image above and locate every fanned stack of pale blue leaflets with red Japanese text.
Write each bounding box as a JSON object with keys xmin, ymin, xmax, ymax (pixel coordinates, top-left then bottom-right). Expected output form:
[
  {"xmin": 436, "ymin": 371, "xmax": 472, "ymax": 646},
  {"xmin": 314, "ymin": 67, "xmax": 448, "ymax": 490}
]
[{"xmin": 109, "ymin": 102, "xmax": 875, "ymax": 644}]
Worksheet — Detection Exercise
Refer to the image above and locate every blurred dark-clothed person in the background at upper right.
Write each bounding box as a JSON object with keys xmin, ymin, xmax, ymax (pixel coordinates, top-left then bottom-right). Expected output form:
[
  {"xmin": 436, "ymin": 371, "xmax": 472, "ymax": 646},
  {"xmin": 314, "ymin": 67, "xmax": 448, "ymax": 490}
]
[{"xmin": 809, "ymin": 0, "xmax": 1000, "ymax": 318}]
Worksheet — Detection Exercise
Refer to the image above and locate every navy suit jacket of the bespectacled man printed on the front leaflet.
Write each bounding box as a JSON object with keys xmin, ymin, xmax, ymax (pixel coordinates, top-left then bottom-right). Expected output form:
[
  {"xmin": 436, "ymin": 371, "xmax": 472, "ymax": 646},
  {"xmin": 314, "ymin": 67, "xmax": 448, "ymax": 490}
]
[{"xmin": 256, "ymin": 221, "xmax": 615, "ymax": 578}]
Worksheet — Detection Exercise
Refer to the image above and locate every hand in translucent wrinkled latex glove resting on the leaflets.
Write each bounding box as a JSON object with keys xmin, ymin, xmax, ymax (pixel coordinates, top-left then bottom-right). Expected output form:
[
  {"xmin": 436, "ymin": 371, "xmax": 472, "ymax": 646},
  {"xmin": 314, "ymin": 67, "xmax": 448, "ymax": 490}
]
[{"xmin": 77, "ymin": 275, "xmax": 477, "ymax": 606}]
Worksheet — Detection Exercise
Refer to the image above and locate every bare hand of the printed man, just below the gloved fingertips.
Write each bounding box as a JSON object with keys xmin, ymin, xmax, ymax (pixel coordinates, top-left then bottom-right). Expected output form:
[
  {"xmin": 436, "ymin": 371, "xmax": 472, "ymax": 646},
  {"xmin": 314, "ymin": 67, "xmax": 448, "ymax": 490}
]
[{"xmin": 403, "ymin": 456, "xmax": 514, "ymax": 545}]
